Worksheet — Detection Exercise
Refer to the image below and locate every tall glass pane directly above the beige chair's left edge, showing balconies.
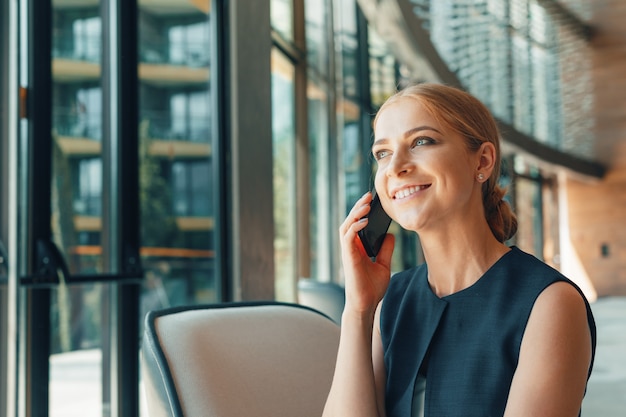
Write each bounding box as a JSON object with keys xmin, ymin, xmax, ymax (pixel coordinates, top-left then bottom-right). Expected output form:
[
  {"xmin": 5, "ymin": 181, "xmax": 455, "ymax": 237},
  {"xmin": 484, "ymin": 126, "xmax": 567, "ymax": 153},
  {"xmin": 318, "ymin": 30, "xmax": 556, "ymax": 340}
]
[{"xmin": 138, "ymin": 0, "xmax": 214, "ymax": 317}]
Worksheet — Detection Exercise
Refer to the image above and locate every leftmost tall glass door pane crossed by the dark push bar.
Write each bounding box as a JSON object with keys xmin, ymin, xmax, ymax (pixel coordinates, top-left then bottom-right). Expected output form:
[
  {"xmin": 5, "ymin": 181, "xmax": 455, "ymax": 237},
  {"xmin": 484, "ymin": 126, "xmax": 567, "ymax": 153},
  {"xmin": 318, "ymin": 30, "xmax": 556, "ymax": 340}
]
[{"xmin": 50, "ymin": 1, "xmax": 104, "ymax": 417}]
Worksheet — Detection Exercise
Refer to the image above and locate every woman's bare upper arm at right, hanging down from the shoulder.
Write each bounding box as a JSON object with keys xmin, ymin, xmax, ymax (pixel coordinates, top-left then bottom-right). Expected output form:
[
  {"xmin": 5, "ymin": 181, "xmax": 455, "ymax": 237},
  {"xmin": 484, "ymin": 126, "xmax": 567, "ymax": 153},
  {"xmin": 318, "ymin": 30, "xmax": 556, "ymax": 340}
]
[{"xmin": 504, "ymin": 282, "xmax": 592, "ymax": 417}]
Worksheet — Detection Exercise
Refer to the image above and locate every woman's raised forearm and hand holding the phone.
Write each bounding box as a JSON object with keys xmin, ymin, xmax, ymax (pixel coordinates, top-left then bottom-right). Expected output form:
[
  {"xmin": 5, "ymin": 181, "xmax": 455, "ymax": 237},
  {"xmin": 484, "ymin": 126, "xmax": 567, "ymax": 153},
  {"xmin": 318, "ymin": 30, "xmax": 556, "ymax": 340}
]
[{"xmin": 323, "ymin": 193, "xmax": 394, "ymax": 417}]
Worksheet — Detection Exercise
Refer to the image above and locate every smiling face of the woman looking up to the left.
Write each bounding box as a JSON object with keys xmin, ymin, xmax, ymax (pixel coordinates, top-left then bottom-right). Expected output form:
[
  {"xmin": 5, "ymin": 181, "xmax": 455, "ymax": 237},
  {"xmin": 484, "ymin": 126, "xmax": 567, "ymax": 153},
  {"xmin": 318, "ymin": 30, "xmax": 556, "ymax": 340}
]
[{"xmin": 372, "ymin": 98, "xmax": 482, "ymax": 232}]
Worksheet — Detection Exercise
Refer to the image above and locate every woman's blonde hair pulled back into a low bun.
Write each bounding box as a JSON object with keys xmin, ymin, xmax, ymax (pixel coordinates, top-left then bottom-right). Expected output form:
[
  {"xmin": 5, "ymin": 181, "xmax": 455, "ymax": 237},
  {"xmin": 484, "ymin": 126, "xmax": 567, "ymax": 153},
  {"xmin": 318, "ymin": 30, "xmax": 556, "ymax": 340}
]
[{"xmin": 373, "ymin": 83, "xmax": 517, "ymax": 242}]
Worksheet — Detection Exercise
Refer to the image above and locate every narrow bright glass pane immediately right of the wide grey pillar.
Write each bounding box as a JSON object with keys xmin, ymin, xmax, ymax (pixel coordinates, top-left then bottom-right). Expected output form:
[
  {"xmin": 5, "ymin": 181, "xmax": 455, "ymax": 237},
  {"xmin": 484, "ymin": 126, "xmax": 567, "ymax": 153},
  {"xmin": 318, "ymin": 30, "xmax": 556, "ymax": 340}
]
[{"xmin": 272, "ymin": 48, "xmax": 298, "ymax": 302}]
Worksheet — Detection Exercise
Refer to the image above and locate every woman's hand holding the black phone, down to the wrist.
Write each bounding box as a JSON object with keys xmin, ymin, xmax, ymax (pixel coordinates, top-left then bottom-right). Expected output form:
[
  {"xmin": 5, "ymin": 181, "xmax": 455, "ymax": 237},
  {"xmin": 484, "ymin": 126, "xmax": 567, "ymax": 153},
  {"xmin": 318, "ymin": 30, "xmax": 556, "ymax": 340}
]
[{"xmin": 339, "ymin": 192, "xmax": 394, "ymax": 315}]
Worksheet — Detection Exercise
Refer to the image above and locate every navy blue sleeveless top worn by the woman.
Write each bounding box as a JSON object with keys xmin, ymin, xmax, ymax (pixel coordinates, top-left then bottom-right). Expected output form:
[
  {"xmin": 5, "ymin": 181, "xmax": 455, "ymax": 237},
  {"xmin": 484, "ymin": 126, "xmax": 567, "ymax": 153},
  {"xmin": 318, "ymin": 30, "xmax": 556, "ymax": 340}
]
[{"xmin": 380, "ymin": 247, "xmax": 596, "ymax": 417}]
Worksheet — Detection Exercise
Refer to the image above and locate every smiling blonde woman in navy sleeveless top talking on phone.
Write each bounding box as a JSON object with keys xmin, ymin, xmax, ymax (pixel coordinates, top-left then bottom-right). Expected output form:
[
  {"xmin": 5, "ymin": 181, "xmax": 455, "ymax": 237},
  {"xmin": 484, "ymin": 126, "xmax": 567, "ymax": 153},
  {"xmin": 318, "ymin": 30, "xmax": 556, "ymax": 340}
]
[{"xmin": 324, "ymin": 84, "xmax": 595, "ymax": 417}]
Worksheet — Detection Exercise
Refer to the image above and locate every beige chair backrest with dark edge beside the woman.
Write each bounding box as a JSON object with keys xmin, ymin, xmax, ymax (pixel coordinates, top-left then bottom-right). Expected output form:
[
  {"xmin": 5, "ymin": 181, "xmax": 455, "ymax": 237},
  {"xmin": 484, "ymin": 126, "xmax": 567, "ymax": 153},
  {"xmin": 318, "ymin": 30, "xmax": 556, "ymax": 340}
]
[{"xmin": 141, "ymin": 303, "xmax": 339, "ymax": 417}]
